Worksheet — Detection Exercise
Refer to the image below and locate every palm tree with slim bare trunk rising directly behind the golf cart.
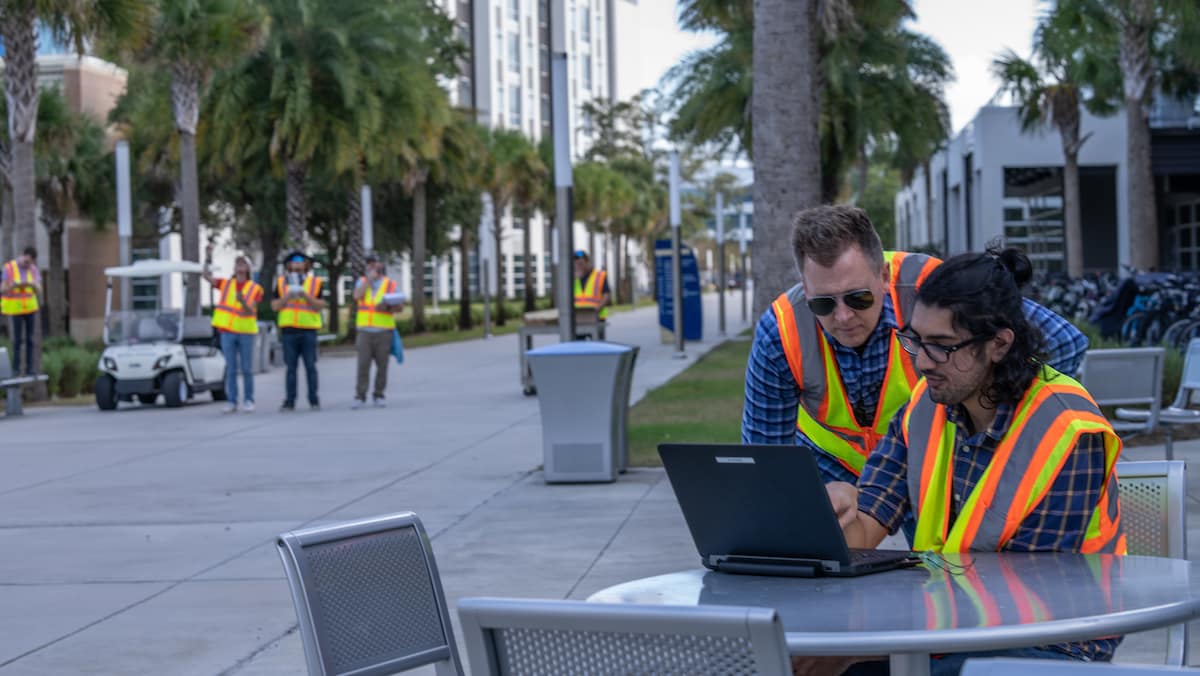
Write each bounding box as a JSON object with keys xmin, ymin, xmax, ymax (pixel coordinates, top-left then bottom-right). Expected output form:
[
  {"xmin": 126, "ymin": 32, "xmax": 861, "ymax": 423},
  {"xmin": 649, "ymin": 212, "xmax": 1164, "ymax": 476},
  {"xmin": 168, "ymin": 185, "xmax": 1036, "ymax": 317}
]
[{"xmin": 143, "ymin": 0, "xmax": 266, "ymax": 316}]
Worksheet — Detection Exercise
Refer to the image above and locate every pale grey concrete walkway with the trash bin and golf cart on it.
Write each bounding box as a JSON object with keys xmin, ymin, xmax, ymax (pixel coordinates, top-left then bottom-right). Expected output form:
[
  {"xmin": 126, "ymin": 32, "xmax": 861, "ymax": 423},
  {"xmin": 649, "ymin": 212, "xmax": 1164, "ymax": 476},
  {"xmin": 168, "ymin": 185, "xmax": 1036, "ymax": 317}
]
[{"xmin": 0, "ymin": 294, "xmax": 744, "ymax": 675}]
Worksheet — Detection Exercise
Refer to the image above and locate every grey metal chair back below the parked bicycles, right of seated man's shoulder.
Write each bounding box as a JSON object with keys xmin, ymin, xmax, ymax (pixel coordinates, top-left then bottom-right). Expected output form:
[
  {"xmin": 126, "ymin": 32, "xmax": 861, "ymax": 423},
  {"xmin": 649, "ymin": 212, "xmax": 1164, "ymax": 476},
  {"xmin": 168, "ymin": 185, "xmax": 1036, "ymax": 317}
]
[{"xmin": 1079, "ymin": 347, "xmax": 1166, "ymax": 429}]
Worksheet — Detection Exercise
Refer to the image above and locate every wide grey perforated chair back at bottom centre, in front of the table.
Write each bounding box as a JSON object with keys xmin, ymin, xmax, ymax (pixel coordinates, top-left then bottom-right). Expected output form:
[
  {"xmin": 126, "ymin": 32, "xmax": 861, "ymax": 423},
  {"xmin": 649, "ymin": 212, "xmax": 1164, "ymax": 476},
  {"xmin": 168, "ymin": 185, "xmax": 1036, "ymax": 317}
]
[{"xmin": 458, "ymin": 598, "xmax": 792, "ymax": 676}]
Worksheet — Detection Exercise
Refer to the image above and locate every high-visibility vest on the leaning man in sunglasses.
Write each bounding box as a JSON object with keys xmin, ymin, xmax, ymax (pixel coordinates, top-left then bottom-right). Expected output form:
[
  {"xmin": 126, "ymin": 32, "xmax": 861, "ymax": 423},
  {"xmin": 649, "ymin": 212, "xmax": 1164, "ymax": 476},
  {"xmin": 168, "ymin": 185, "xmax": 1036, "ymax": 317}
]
[{"xmin": 772, "ymin": 251, "xmax": 942, "ymax": 475}]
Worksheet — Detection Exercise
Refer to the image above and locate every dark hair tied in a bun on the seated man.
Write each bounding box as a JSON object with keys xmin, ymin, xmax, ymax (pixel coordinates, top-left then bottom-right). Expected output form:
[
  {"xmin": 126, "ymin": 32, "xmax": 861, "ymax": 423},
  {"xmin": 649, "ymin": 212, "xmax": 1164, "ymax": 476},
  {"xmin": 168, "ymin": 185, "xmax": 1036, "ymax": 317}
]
[{"xmin": 917, "ymin": 247, "xmax": 1044, "ymax": 406}]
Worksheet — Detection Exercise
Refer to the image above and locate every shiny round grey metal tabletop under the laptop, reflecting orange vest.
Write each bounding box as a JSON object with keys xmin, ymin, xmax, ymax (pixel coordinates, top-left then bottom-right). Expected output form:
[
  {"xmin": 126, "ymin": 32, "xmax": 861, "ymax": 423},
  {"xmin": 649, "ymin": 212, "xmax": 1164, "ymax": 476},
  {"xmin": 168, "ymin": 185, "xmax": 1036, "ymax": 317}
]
[{"xmin": 589, "ymin": 552, "xmax": 1194, "ymax": 633}]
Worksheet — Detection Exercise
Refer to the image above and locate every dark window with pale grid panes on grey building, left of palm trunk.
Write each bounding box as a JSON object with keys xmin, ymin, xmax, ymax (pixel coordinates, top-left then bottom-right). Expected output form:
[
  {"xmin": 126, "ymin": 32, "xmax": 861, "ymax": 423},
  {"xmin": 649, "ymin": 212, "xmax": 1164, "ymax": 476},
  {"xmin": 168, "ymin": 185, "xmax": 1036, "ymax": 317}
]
[{"xmin": 1002, "ymin": 167, "xmax": 1067, "ymax": 273}]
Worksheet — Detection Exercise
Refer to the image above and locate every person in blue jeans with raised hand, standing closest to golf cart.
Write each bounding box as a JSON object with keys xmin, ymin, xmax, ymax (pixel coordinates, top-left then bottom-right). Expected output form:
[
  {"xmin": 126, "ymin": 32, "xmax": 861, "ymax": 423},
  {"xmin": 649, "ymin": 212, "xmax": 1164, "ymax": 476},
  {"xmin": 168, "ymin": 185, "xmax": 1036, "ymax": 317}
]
[{"xmin": 204, "ymin": 244, "xmax": 263, "ymax": 413}]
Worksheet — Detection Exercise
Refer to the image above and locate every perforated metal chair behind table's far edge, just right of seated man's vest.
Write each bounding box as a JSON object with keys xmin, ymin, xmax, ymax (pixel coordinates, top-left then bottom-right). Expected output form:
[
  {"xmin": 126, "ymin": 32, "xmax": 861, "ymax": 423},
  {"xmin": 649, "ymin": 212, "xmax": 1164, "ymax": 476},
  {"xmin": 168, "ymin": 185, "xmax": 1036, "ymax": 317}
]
[{"xmin": 1117, "ymin": 460, "xmax": 1188, "ymax": 665}]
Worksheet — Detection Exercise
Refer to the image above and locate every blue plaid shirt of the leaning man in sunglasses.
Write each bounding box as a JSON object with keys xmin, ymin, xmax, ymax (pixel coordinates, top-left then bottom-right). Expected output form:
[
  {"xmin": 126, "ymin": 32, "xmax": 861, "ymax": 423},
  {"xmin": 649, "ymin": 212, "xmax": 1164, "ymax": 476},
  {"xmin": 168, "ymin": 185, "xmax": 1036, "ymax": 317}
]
[{"xmin": 742, "ymin": 295, "xmax": 1087, "ymax": 484}]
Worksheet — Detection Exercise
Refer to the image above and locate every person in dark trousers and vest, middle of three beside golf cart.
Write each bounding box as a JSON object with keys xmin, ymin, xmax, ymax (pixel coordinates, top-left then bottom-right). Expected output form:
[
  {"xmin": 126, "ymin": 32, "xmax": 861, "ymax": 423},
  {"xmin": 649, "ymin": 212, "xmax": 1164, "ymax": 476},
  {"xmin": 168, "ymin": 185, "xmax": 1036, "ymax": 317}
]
[{"xmin": 271, "ymin": 251, "xmax": 325, "ymax": 412}]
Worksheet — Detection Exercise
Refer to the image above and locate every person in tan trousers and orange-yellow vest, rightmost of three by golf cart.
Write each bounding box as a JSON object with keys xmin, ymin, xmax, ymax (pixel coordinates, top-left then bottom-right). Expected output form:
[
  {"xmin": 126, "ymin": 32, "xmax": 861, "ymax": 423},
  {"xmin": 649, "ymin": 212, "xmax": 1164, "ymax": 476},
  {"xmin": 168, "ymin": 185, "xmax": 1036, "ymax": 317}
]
[{"xmin": 350, "ymin": 256, "xmax": 404, "ymax": 408}]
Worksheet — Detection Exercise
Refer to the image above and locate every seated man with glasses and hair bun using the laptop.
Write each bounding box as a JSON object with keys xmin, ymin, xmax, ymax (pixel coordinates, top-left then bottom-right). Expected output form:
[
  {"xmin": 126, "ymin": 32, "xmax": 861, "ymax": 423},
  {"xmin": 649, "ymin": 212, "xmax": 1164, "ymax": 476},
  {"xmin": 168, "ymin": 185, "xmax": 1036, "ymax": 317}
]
[{"xmin": 827, "ymin": 249, "xmax": 1126, "ymax": 676}]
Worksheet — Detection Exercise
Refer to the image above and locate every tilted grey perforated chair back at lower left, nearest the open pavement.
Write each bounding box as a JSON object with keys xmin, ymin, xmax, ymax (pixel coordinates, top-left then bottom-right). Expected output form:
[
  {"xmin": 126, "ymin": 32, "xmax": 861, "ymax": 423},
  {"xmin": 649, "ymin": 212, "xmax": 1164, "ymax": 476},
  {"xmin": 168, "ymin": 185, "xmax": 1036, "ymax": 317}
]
[{"xmin": 277, "ymin": 513, "xmax": 462, "ymax": 676}]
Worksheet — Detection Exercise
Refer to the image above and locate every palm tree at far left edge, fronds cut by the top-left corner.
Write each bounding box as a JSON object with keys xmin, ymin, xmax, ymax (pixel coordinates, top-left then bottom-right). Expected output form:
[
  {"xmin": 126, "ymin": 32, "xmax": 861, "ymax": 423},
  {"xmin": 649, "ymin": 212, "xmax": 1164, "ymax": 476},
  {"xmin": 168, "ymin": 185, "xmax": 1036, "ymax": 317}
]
[{"xmin": 0, "ymin": 0, "xmax": 150, "ymax": 259}]
